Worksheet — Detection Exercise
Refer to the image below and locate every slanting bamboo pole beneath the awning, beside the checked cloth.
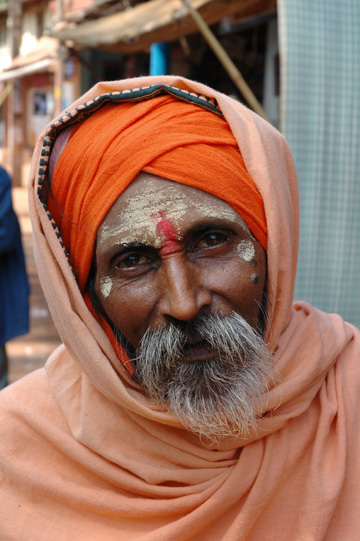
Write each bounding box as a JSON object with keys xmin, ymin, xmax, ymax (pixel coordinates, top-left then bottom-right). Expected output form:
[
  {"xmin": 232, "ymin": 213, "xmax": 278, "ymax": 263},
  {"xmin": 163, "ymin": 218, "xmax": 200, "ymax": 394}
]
[{"xmin": 183, "ymin": 0, "xmax": 270, "ymax": 122}]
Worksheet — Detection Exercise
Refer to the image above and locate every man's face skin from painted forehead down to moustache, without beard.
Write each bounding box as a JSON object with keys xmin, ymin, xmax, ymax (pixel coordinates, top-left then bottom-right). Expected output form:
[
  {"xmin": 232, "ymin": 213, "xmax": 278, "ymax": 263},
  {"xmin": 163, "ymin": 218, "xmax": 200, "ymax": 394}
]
[{"xmin": 96, "ymin": 173, "xmax": 266, "ymax": 350}]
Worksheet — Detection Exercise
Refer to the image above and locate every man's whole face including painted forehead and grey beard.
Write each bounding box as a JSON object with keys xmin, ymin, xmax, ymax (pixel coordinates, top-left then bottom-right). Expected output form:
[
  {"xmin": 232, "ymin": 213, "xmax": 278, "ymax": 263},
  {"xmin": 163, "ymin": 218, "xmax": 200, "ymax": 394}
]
[{"xmin": 95, "ymin": 173, "xmax": 272, "ymax": 442}]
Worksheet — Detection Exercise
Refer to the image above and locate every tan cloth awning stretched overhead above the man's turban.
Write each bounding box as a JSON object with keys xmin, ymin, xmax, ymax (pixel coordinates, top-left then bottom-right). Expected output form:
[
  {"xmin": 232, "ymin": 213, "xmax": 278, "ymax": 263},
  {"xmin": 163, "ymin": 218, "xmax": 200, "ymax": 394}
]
[{"xmin": 52, "ymin": 0, "xmax": 276, "ymax": 54}]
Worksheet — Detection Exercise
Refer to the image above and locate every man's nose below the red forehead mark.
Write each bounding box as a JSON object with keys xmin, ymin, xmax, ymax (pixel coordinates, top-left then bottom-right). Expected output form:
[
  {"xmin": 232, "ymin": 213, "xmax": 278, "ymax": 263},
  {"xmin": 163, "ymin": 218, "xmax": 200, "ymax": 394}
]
[{"xmin": 158, "ymin": 254, "xmax": 211, "ymax": 321}]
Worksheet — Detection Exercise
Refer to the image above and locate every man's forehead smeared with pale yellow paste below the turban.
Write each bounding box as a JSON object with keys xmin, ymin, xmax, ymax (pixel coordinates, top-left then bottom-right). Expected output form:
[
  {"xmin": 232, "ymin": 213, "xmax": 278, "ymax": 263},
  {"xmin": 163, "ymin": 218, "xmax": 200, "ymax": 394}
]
[{"xmin": 98, "ymin": 173, "xmax": 248, "ymax": 247}]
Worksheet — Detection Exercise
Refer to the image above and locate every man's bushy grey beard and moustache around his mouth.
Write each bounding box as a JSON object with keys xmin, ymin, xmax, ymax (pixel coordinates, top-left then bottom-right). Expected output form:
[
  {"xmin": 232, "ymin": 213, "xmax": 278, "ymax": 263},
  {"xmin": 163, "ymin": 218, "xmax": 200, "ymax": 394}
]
[{"xmin": 132, "ymin": 313, "xmax": 274, "ymax": 443}]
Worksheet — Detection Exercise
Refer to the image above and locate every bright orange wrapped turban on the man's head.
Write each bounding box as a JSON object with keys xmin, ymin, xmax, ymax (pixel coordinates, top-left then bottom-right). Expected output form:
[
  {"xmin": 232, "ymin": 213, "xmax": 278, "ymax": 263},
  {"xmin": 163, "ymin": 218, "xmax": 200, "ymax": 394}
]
[{"xmin": 48, "ymin": 96, "xmax": 266, "ymax": 292}]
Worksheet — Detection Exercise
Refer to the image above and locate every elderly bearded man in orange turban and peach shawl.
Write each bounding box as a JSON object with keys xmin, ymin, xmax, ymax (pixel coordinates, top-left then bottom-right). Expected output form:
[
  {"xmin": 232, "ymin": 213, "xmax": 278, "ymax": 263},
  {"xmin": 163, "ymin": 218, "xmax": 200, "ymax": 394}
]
[{"xmin": 0, "ymin": 77, "xmax": 360, "ymax": 541}]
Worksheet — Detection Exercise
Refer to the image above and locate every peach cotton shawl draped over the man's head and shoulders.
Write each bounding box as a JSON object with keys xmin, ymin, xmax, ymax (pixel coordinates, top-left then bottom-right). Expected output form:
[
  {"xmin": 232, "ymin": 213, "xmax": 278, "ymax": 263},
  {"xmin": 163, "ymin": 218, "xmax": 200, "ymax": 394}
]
[{"xmin": 0, "ymin": 77, "xmax": 360, "ymax": 541}]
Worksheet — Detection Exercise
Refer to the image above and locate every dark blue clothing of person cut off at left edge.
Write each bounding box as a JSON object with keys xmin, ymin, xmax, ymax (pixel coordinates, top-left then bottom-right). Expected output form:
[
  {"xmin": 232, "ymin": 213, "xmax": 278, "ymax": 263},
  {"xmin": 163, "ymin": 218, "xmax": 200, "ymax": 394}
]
[{"xmin": 0, "ymin": 167, "xmax": 29, "ymax": 345}]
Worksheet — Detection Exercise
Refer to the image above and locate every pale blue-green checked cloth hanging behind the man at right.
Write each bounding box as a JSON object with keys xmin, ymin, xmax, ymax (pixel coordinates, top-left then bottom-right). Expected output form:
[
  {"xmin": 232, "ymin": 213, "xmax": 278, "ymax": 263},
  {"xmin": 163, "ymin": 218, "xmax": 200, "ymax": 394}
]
[{"xmin": 278, "ymin": 0, "xmax": 360, "ymax": 327}]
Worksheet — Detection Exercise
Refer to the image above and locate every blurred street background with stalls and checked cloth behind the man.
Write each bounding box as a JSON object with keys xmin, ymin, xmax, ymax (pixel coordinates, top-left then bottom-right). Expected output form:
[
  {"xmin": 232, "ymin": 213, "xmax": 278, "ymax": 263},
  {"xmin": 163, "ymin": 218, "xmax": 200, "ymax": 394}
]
[{"xmin": 0, "ymin": 0, "xmax": 360, "ymax": 381}]
